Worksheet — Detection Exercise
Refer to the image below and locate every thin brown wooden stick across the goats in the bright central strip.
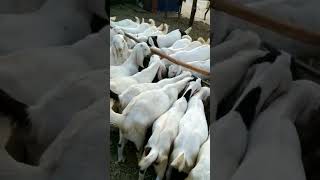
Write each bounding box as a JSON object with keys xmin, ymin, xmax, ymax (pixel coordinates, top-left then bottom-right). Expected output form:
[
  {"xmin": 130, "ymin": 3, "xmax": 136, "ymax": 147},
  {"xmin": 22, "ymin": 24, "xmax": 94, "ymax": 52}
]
[{"xmin": 111, "ymin": 25, "xmax": 210, "ymax": 76}]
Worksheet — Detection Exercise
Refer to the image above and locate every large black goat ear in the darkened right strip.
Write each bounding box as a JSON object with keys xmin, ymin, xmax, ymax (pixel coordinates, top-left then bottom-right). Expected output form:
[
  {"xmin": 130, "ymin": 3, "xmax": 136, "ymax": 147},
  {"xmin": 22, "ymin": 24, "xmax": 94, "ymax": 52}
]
[{"xmin": 235, "ymin": 87, "xmax": 261, "ymax": 129}]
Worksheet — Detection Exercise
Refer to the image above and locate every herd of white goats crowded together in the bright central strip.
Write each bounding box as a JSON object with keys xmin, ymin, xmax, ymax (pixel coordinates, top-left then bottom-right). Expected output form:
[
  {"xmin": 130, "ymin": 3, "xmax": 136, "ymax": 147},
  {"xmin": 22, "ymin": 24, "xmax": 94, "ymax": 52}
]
[{"xmin": 110, "ymin": 18, "xmax": 210, "ymax": 180}]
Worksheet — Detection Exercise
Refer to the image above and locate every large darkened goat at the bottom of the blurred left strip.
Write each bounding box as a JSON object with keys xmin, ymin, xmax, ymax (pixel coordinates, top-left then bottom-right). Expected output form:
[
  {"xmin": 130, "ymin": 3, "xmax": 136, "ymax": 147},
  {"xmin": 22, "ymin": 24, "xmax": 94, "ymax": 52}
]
[{"xmin": 0, "ymin": 97, "xmax": 107, "ymax": 180}]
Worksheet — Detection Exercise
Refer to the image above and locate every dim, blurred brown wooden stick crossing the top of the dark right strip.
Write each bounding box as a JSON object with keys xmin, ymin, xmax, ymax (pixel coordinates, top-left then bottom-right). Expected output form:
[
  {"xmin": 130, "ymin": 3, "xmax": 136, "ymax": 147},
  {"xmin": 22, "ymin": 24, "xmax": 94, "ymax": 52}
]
[{"xmin": 211, "ymin": 0, "xmax": 320, "ymax": 46}]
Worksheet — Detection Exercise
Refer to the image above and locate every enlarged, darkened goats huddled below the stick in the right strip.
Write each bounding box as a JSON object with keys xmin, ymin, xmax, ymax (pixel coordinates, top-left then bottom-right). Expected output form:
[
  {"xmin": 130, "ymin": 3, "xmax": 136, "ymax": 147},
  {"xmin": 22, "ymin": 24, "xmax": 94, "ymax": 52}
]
[{"xmin": 210, "ymin": 29, "xmax": 320, "ymax": 180}]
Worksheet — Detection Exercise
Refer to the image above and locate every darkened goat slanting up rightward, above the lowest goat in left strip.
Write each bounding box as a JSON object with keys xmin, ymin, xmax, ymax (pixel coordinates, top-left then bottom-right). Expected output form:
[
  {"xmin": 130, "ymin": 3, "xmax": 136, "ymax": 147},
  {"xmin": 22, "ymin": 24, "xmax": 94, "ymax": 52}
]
[{"xmin": 6, "ymin": 69, "xmax": 107, "ymax": 164}]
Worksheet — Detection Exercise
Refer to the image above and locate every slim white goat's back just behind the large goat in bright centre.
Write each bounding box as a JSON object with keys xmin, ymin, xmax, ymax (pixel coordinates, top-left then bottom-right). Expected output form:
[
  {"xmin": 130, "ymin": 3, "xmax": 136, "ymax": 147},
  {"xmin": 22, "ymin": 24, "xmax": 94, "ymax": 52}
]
[{"xmin": 119, "ymin": 72, "xmax": 191, "ymax": 109}]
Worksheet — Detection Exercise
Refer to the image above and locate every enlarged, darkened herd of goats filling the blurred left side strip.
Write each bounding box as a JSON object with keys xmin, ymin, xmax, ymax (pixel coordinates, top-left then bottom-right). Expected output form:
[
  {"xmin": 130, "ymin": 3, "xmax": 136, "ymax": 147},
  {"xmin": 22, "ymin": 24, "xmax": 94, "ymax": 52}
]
[{"xmin": 0, "ymin": 0, "xmax": 110, "ymax": 180}]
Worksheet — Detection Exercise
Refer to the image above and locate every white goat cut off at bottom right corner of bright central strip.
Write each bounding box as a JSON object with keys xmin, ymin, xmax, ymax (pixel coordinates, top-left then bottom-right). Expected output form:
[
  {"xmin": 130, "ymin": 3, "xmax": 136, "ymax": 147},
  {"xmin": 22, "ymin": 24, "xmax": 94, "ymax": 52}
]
[{"xmin": 186, "ymin": 136, "xmax": 210, "ymax": 180}]
